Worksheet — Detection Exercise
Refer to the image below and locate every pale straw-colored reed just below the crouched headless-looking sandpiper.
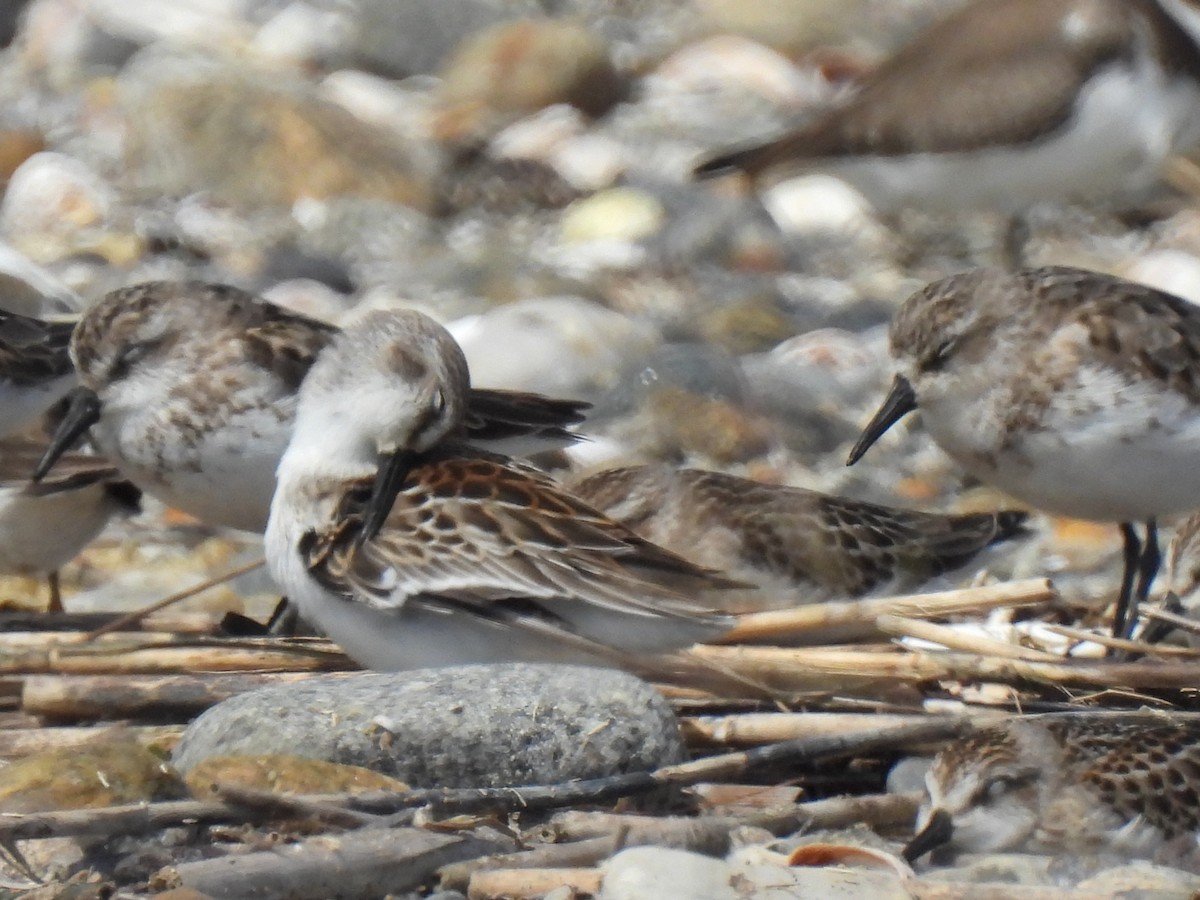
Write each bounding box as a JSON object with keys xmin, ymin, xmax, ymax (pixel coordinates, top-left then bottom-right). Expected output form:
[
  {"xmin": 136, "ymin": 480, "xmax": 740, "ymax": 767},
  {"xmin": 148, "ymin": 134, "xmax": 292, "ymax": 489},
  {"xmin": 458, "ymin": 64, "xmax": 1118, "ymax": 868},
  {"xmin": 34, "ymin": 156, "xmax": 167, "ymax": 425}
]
[{"xmin": 721, "ymin": 578, "xmax": 1058, "ymax": 643}]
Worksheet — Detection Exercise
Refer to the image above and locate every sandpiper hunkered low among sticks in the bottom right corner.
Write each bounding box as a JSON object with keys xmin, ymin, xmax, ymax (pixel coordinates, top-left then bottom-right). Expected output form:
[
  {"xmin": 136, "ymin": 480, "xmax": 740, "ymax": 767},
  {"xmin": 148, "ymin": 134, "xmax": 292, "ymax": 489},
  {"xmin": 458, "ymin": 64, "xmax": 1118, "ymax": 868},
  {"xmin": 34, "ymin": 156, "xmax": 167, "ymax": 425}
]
[{"xmin": 906, "ymin": 713, "xmax": 1200, "ymax": 859}]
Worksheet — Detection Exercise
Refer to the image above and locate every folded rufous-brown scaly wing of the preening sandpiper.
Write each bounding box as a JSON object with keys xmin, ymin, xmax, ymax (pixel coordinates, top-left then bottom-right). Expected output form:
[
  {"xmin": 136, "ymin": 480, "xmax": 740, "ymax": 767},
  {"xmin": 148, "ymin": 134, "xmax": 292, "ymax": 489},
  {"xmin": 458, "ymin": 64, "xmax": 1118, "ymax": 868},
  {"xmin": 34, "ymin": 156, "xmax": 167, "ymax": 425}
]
[{"xmin": 301, "ymin": 448, "xmax": 743, "ymax": 616}]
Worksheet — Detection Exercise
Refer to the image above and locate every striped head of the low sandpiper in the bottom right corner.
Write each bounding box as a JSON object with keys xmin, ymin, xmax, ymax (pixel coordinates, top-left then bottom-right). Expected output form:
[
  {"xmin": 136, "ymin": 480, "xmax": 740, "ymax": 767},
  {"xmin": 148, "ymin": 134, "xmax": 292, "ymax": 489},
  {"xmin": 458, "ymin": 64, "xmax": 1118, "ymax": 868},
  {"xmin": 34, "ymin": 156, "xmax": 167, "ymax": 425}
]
[{"xmin": 905, "ymin": 730, "xmax": 1049, "ymax": 860}]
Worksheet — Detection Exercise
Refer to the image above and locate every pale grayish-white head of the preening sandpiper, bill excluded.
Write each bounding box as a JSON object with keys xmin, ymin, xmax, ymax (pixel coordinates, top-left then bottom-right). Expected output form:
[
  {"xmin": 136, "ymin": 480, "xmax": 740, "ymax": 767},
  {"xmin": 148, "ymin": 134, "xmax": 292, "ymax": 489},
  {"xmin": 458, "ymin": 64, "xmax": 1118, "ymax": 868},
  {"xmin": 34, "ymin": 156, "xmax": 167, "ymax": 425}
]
[{"xmin": 296, "ymin": 310, "xmax": 470, "ymax": 456}]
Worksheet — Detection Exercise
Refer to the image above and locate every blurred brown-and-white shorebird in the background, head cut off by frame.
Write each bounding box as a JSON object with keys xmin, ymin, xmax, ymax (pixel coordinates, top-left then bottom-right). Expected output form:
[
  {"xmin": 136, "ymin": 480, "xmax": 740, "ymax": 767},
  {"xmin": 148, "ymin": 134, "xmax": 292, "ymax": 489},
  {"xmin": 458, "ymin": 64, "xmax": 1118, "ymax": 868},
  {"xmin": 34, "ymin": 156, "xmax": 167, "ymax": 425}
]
[{"xmin": 696, "ymin": 0, "xmax": 1200, "ymax": 211}]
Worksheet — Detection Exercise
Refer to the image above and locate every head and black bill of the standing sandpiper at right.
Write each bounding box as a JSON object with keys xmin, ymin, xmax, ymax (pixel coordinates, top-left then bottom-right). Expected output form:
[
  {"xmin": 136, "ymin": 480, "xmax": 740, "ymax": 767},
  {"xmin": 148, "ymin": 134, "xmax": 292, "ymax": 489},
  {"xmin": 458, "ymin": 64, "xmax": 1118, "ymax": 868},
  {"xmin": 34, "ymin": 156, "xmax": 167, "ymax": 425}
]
[{"xmin": 846, "ymin": 269, "xmax": 1014, "ymax": 466}]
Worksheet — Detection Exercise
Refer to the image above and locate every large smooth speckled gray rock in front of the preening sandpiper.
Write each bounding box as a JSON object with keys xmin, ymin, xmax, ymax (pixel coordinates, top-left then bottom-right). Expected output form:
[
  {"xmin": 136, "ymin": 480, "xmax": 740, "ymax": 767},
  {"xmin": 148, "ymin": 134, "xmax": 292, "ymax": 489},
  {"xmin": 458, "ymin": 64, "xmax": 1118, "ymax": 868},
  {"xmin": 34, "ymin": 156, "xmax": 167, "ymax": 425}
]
[{"xmin": 174, "ymin": 665, "xmax": 684, "ymax": 787}]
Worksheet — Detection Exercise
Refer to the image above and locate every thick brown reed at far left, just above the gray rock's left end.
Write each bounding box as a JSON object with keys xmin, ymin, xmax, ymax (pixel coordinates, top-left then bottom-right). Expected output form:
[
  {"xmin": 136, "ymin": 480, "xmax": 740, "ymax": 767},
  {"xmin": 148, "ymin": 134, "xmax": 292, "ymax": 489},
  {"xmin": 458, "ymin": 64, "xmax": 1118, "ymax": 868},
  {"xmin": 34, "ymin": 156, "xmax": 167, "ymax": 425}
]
[{"xmin": 22, "ymin": 672, "xmax": 328, "ymax": 724}]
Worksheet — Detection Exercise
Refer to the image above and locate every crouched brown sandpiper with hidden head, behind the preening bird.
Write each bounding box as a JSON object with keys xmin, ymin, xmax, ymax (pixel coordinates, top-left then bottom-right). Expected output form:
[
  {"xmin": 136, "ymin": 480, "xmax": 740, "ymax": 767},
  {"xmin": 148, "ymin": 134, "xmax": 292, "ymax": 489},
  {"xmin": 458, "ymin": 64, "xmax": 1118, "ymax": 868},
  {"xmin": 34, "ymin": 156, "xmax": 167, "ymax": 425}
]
[{"xmin": 569, "ymin": 464, "xmax": 1027, "ymax": 605}]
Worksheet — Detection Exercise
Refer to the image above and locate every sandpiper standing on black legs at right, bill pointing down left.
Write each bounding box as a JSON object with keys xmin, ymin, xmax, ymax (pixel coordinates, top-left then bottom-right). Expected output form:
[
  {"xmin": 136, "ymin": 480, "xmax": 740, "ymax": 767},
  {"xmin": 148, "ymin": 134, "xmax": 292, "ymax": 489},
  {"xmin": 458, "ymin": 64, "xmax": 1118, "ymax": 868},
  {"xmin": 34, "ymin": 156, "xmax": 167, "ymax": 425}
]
[{"xmin": 848, "ymin": 268, "xmax": 1200, "ymax": 636}]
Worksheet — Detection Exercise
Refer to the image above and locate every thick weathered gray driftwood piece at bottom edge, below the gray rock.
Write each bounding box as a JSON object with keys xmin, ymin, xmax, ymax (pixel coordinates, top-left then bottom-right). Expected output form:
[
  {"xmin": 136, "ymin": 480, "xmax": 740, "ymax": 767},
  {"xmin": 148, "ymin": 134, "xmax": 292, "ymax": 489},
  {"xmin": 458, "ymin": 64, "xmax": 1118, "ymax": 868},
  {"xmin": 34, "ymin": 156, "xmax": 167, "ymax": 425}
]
[{"xmin": 168, "ymin": 828, "xmax": 500, "ymax": 900}]
